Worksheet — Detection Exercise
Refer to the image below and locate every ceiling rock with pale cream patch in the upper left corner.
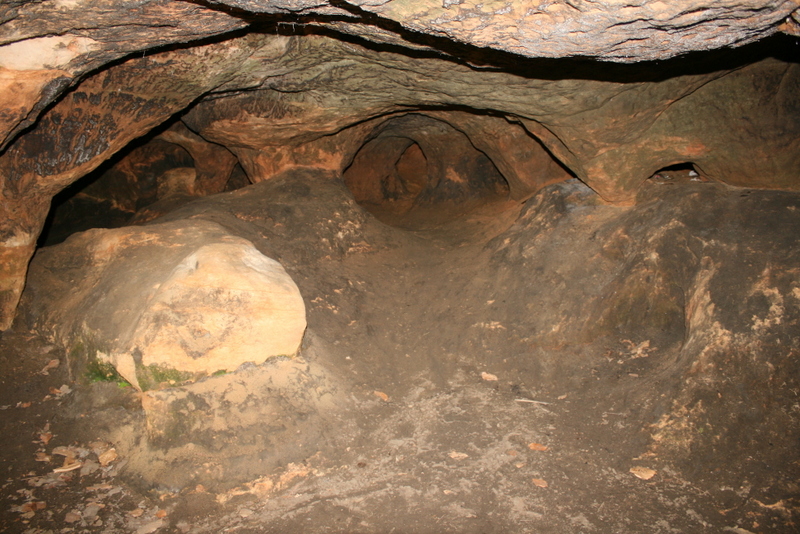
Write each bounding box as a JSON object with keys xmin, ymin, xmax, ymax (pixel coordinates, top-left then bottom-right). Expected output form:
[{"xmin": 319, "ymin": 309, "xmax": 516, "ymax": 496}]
[{"xmin": 0, "ymin": 0, "xmax": 245, "ymax": 153}]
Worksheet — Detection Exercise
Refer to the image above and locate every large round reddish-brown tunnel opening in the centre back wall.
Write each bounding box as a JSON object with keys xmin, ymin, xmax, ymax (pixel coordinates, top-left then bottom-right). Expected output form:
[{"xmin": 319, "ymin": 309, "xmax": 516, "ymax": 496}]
[{"xmin": 343, "ymin": 113, "xmax": 515, "ymax": 231}]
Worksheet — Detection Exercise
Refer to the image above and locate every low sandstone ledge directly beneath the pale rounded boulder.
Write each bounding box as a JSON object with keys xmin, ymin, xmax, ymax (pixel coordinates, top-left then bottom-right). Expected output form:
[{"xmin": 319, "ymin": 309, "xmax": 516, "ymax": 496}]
[{"xmin": 142, "ymin": 357, "xmax": 338, "ymax": 460}]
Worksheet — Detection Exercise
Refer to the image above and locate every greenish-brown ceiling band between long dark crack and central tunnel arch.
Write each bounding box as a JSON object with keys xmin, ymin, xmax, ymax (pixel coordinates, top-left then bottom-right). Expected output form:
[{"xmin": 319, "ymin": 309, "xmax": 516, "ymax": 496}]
[{"xmin": 184, "ymin": 37, "xmax": 800, "ymax": 203}]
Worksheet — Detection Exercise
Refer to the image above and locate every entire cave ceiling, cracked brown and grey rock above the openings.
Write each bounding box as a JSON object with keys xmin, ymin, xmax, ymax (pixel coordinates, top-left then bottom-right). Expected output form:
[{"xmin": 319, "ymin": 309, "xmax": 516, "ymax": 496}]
[{"xmin": 0, "ymin": 0, "xmax": 800, "ymax": 329}]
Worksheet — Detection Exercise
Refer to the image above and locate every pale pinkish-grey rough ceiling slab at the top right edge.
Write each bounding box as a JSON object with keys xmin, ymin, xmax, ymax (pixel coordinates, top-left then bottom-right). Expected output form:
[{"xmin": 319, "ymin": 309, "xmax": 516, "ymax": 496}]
[{"xmin": 353, "ymin": 0, "xmax": 797, "ymax": 61}]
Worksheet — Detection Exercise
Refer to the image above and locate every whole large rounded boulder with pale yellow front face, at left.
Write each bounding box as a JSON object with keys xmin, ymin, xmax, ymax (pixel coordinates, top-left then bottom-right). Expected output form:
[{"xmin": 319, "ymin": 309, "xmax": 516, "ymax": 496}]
[{"xmin": 19, "ymin": 221, "xmax": 306, "ymax": 389}]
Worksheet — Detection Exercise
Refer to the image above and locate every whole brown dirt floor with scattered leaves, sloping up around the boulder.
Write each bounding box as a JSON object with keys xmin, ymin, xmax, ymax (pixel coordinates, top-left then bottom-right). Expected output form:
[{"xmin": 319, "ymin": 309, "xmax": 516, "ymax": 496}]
[{"xmin": 0, "ymin": 172, "xmax": 800, "ymax": 534}]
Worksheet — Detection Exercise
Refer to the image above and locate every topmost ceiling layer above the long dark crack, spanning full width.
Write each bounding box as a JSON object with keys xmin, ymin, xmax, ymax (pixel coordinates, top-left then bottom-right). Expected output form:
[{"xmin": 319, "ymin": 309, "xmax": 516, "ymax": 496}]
[{"xmin": 0, "ymin": 0, "xmax": 800, "ymax": 153}]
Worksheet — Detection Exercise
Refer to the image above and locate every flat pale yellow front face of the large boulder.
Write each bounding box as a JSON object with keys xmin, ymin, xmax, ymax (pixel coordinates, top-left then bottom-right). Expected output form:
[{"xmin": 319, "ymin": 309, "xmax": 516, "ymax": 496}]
[{"xmin": 126, "ymin": 243, "xmax": 306, "ymax": 378}]
